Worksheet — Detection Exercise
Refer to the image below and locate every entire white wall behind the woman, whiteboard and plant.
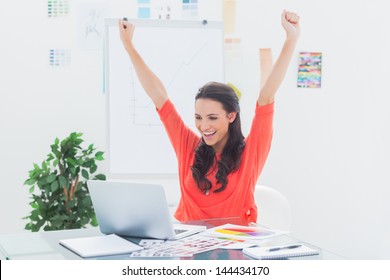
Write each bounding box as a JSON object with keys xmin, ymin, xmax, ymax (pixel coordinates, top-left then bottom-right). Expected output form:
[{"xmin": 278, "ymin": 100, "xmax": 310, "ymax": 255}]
[{"xmin": 0, "ymin": 0, "xmax": 390, "ymax": 259}]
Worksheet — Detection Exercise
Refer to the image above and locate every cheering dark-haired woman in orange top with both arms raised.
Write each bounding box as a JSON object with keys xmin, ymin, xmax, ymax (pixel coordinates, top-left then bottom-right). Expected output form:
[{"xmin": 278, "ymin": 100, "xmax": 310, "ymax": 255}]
[{"xmin": 119, "ymin": 11, "xmax": 300, "ymax": 223}]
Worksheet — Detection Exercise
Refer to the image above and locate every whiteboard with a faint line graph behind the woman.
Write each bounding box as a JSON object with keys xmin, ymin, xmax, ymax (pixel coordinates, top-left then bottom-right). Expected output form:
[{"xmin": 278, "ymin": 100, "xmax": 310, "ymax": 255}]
[{"xmin": 104, "ymin": 19, "xmax": 224, "ymax": 177}]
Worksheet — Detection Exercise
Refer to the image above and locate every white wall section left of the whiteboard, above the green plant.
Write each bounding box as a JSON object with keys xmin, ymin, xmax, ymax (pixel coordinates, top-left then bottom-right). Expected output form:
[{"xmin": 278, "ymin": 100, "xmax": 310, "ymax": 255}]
[{"xmin": 0, "ymin": 1, "xmax": 105, "ymax": 235}]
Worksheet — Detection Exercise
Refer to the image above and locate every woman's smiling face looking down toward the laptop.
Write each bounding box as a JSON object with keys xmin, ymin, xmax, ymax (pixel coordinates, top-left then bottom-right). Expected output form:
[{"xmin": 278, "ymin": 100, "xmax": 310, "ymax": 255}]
[{"xmin": 195, "ymin": 98, "xmax": 236, "ymax": 153}]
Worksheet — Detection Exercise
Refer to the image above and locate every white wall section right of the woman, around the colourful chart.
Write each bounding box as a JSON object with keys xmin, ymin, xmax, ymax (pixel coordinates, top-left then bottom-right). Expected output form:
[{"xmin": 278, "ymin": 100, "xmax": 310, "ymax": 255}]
[{"xmin": 240, "ymin": 1, "xmax": 390, "ymax": 259}]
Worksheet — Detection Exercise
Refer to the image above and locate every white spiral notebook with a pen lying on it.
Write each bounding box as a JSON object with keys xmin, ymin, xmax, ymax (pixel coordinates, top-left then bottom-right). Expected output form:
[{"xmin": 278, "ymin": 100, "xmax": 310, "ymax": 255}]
[{"xmin": 242, "ymin": 244, "xmax": 319, "ymax": 260}]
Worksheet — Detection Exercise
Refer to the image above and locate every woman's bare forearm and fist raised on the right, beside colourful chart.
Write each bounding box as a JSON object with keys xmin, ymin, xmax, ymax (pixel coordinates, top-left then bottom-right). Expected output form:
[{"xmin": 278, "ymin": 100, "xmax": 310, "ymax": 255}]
[{"xmin": 257, "ymin": 11, "xmax": 300, "ymax": 105}]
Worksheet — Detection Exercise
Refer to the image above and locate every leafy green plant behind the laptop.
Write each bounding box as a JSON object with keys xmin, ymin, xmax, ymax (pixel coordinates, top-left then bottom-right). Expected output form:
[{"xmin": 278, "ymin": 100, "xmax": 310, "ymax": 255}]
[{"xmin": 24, "ymin": 132, "xmax": 106, "ymax": 231}]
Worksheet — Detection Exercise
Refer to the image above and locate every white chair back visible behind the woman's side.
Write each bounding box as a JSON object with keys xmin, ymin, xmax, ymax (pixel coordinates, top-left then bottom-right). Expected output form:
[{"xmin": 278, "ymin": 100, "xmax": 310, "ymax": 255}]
[{"xmin": 255, "ymin": 185, "xmax": 291, "ymax": 230}]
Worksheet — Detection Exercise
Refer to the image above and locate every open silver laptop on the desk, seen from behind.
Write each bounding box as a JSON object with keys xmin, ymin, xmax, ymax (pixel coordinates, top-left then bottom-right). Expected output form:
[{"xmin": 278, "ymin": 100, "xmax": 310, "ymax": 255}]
[{"xmin": 87, "ymin": 180, "xmax": 206, "ymax": 240}]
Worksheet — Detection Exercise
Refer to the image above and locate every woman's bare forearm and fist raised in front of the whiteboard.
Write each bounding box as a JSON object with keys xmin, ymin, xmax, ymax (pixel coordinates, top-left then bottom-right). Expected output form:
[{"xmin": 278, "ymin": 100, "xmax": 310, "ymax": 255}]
[{"xmin": 118, "ymin": 20, "xmax": 168, "ymax": 109}]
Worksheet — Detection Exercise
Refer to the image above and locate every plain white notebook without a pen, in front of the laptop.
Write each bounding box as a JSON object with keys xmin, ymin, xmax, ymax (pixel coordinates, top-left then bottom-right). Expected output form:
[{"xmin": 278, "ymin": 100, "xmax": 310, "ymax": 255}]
[{"xmin": 60, "ymin": 234, "xmax": 143, "ymax": 258}]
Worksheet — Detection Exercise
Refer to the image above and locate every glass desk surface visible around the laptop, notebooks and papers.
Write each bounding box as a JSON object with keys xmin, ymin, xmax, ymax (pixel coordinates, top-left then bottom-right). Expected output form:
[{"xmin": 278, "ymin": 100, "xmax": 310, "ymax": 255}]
[{"xmin": 0, "ymin": 220, "xmax": 343, "ymax": 260}]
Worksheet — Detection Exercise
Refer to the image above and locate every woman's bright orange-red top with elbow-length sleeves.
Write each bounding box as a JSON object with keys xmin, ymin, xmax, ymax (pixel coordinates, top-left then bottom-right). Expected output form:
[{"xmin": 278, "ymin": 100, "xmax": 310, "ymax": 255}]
[{"xmin": 158, "ymin": 100, "xmax": 274, "ymax": 222}]
